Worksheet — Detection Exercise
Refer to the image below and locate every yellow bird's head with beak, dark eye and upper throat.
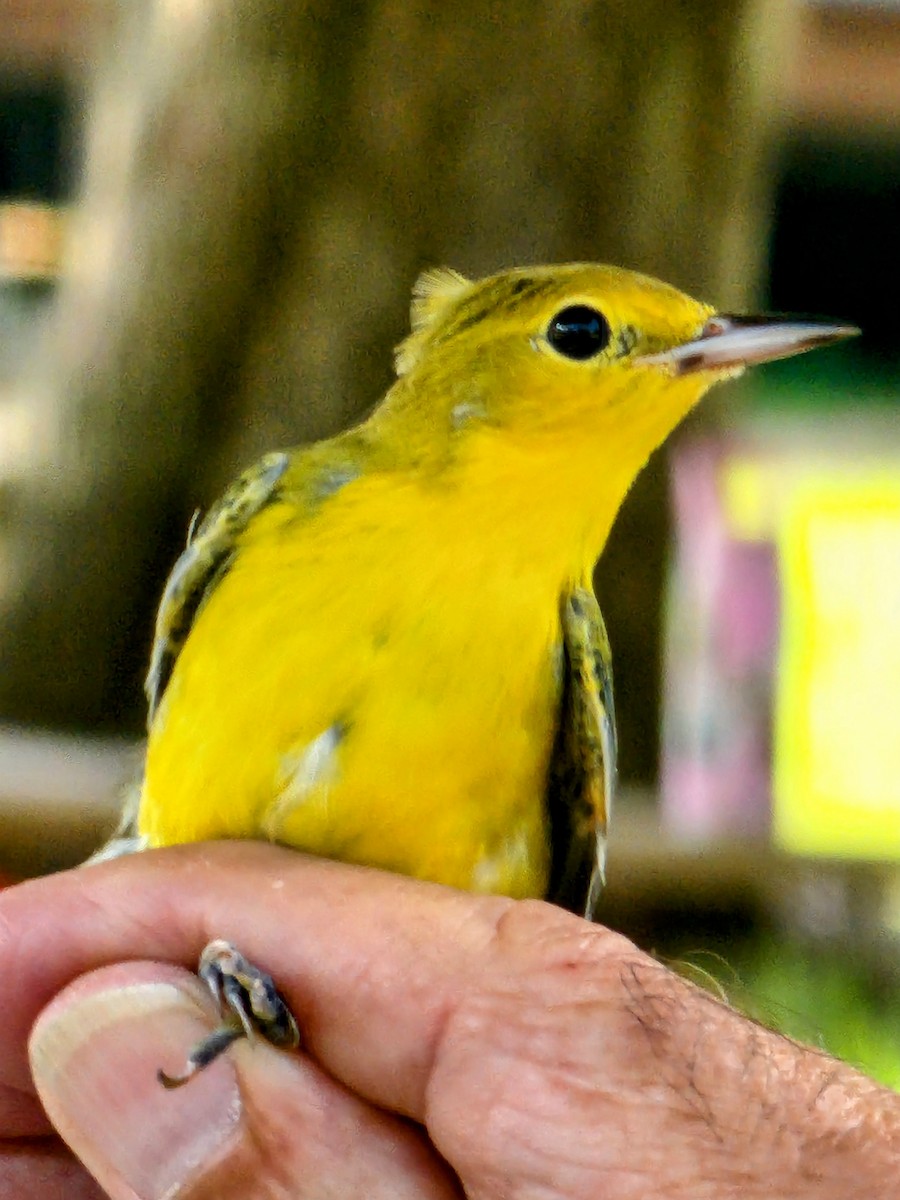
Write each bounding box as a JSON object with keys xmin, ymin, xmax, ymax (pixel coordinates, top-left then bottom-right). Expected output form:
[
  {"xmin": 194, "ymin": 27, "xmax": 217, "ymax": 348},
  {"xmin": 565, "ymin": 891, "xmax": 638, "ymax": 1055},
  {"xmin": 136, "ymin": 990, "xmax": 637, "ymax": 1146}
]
[{"xmin": 385, "ymin": 263, "xmax": 858, "ymax": 549}]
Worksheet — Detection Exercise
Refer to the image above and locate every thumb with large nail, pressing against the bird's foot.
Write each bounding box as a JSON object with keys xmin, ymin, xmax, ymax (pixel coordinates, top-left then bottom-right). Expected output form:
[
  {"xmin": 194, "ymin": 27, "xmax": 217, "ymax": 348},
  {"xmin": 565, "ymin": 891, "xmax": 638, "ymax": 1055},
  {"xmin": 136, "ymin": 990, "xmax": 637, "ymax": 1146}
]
[{"xmin": 31, "ymin": 962, "xmax": 460, "ymax": 1200}]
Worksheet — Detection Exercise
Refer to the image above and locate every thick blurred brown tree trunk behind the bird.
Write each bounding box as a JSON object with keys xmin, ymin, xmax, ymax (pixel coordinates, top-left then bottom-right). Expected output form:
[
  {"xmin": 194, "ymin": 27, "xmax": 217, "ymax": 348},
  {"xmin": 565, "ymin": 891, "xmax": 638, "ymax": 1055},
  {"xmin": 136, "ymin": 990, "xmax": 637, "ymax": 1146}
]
[{"xmin": 0, "ymin": 0, "xmax": 801, "ymax": 779}]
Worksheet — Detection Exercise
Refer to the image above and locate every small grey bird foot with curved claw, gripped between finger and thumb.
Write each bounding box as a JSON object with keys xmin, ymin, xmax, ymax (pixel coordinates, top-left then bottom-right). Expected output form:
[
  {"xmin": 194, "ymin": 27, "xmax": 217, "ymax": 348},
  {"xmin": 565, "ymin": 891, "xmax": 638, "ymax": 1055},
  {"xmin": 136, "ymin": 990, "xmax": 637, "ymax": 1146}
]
[{"xmin": 156, "ymin": 938, "xmax": 300, "ymax": 1088}]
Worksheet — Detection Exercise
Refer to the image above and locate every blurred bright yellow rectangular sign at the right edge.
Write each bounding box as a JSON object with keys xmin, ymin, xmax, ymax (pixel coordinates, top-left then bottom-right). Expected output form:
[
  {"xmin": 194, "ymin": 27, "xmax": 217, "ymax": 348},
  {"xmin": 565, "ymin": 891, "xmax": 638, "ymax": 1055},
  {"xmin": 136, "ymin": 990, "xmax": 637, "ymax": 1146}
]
[{"xmin": 774, "ymin": 468, "xmax": 900, "ymax": 859}]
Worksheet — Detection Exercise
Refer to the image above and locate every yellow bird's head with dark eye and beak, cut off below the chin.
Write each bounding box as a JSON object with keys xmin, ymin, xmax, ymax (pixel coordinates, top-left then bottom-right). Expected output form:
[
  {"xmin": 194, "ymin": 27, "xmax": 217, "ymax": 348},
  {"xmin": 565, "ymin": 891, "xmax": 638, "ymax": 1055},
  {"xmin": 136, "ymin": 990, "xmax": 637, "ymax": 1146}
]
[{"xmin": 396, "ymin": 263, "xmax": 858, "ymax": 440}]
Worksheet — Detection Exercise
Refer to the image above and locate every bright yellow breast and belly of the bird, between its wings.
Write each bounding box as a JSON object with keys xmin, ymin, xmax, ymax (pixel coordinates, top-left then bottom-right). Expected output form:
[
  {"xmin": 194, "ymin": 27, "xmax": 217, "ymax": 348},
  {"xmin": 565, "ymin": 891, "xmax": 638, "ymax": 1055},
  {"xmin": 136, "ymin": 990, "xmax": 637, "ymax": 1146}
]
[{"xmin": 140, "ymin": 468, "xmax": 578, "ymax": 896}]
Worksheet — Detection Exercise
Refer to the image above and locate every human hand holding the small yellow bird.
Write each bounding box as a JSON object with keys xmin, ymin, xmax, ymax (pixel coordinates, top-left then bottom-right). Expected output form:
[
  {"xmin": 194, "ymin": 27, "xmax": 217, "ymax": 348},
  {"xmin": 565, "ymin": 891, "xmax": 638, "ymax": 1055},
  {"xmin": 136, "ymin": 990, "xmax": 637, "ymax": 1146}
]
[{"xmin": 0, "ymin": 842, "xmax": 900, "ymax": 1200}]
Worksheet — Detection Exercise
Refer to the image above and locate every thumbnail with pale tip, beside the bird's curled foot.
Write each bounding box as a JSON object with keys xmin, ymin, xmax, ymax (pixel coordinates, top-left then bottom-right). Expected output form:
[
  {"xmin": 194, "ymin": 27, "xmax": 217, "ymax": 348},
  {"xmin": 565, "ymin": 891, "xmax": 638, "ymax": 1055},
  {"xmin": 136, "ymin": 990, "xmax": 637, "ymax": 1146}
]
[{"xmin": 30, "ymin": 983, "xmax": 241, "ymax": 1200}]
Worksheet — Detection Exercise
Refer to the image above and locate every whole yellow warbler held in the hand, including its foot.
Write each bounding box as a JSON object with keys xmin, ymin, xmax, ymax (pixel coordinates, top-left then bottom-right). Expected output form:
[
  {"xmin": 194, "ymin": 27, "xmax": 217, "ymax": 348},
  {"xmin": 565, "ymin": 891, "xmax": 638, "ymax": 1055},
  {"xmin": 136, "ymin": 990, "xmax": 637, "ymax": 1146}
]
[{"xmin": 116, "ymin": 264, "xmax": 854, "ymax": 1084}]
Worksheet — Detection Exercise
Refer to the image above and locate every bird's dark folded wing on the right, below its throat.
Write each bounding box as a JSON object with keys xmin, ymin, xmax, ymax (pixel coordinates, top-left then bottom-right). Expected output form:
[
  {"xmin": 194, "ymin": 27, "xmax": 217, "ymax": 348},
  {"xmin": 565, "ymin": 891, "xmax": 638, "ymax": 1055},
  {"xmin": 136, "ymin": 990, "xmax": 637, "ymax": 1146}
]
[{"xmin": 547, "ymin": 588, "xmax": 616, "ymax": 919}]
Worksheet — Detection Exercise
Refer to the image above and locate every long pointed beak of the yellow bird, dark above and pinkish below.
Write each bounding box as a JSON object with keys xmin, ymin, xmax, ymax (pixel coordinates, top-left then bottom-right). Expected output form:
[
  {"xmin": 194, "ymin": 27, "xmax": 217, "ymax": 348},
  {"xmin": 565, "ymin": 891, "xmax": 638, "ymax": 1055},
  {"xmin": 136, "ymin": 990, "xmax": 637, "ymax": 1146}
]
[{"xmin": 635, "ymin": 313, "xmax": 859, "ymax": 374}]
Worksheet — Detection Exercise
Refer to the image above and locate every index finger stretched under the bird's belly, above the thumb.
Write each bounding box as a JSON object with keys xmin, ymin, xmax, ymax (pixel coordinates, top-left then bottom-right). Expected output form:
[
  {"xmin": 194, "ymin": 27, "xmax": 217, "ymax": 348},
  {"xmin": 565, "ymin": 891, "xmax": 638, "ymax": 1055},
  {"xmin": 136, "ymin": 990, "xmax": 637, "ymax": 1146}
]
[{"xmin": 0, "ymin": 842, "xmax": 619, "ymax": 1120}]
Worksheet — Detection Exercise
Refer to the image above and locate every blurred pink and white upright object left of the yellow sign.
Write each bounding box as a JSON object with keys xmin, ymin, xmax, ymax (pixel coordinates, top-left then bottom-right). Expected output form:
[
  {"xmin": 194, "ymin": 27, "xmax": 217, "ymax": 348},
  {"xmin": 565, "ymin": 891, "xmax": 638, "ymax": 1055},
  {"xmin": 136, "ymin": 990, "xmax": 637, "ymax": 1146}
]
[{"xmin": 661, "ymin": 437, "xmax": 779, "ymax": 840}]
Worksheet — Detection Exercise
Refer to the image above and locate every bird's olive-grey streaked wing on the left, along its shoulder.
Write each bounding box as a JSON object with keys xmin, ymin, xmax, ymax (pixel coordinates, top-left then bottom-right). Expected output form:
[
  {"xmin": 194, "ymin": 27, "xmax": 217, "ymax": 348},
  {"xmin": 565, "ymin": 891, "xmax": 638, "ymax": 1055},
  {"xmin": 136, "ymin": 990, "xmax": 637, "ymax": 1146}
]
[{"xmin": 144, "ymin": 452, "xmax": 290, "ymax": 724}]
